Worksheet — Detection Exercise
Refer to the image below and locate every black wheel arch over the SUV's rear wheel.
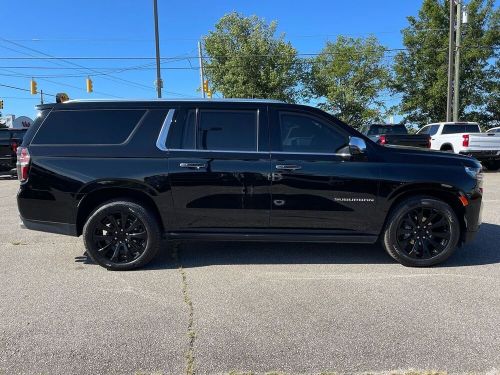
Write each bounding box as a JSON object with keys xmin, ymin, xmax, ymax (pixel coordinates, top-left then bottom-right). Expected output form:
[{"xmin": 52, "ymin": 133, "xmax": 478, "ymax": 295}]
[{"xmin": 76, "ymin": 187, "xmax": 165, "ymax": 236}]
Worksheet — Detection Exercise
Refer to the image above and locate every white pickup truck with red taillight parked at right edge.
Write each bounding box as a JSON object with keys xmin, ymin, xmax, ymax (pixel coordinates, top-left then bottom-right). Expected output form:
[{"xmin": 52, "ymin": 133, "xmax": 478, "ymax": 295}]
[{"xmin": 417, "ymin": 122, "xmax": 500, "ymax": 170}]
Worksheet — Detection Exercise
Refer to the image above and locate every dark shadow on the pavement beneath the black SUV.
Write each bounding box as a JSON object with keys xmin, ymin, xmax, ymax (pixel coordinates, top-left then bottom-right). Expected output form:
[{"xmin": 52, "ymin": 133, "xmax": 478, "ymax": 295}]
[{"xmin": 75, "ymin": 223, "xmax": 500, "ymax": 270}]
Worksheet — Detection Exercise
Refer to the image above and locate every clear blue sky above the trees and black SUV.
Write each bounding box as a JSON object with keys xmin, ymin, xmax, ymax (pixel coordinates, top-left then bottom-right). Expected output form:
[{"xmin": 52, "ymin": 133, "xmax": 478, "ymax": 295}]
[{"xmin": 0, "ymin": 0, "xmax": 446, "ymax": 117}]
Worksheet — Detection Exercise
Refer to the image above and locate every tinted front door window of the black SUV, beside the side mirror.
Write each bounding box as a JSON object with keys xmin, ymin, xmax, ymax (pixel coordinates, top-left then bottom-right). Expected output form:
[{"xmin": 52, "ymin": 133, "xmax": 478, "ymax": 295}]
[{"xmin": 280, "ymin": 112, "xmax": 348, "ymax": 153}]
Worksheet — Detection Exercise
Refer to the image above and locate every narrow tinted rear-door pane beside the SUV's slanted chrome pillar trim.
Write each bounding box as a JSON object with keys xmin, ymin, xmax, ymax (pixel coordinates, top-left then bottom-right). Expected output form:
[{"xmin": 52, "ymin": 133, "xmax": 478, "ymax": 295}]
[{"xmin": 167, "ymin": 109, "xmax": 196, "ymax": 150}]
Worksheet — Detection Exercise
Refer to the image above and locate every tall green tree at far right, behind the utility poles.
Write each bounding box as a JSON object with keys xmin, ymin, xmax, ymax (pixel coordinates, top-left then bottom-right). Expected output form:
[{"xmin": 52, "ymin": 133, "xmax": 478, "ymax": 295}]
[{"xmin": 394, "ymin": 0, "xmax": 500, "ymax": 125}]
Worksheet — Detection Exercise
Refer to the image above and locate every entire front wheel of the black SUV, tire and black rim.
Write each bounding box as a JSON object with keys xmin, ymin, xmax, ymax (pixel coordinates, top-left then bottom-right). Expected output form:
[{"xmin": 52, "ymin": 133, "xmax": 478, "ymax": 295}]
[{"xmin": 382, "ymin": 196, "xmax": 460, "ymax": 267}]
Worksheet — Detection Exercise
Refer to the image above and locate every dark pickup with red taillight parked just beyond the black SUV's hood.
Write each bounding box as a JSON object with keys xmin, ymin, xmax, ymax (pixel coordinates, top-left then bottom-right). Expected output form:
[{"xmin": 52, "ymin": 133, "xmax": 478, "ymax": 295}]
[{"xmin": 361, "ymin": 124, "xmax": 431, "ymax": 148}]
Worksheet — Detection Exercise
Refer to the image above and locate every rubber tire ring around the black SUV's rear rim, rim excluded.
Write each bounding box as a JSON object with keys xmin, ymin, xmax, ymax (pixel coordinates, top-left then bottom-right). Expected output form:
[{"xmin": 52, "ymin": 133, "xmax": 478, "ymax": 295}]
[{"xmin": 83, "ymin": 201, "xmax": 159, "ymax": 270}]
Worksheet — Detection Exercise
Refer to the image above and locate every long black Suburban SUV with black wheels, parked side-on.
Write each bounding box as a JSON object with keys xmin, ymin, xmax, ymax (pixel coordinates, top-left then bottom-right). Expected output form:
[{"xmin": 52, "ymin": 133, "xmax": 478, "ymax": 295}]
[{"xmin": 17, "ymin": 100, "xmax": 482, "ymax": 270}]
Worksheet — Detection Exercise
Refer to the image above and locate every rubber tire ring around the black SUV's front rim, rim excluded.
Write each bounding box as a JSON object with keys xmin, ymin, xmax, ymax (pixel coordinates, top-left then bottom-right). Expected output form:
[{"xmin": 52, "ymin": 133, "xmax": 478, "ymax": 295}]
[{"xmin": 384, "ymin": 198, "xmax": 460, "ymax": 267}]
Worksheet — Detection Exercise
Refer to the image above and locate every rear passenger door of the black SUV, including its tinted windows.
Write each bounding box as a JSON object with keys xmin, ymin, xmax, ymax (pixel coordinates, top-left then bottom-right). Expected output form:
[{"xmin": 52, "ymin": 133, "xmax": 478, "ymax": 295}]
[{"xmin": 167, "ymin": 103, "xmax": 270, "ymax": 231}]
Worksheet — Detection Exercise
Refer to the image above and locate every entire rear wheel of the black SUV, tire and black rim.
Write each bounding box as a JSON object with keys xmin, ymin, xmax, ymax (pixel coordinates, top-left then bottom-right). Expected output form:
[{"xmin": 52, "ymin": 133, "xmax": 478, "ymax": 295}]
[{"xmin": 83, "ymin": 200, "xmax": 161, "ymax": 271}]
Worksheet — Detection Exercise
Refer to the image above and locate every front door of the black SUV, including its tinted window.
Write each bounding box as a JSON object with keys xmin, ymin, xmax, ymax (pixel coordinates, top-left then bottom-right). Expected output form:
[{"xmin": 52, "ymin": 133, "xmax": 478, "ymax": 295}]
[{"xmin": 270, "ymin": 110, "xmax": 378, "ymax": 234}]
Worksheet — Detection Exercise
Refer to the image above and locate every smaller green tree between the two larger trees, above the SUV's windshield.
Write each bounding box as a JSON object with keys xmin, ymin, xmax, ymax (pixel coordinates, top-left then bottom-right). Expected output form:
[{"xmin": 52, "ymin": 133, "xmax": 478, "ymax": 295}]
[{"xmin": 305, "ymin": 36, "xmax": 390, "ymax": 127}]
